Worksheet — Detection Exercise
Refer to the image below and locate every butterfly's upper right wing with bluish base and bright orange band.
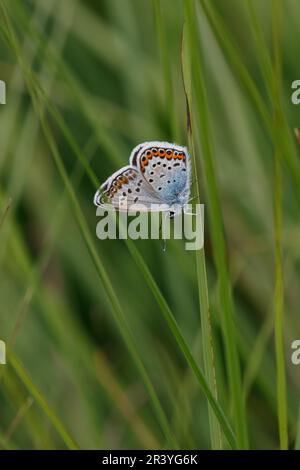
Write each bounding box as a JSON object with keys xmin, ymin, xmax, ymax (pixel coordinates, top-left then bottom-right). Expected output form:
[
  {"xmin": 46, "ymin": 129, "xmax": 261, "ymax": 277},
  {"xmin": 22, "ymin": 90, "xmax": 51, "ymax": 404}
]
[{"xmin": 130, "ymin": 142, "xmax": 191, "ymax": 204}]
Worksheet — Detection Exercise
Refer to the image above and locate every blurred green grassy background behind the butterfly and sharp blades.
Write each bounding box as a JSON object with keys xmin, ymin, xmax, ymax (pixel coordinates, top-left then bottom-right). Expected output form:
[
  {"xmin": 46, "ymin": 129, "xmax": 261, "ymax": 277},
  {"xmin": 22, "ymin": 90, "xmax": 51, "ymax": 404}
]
[{"xmin": 0, "ymin": 0, "xmax": 300, "ymax": 449}]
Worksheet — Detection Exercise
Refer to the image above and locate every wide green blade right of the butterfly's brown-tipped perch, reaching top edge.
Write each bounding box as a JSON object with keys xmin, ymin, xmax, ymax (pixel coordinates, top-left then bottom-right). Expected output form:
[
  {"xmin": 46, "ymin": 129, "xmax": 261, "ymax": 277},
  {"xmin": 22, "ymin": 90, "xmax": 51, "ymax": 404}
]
[{"xmin": 186, "ymin": 0, "xmax": 249, "ymax": 449}]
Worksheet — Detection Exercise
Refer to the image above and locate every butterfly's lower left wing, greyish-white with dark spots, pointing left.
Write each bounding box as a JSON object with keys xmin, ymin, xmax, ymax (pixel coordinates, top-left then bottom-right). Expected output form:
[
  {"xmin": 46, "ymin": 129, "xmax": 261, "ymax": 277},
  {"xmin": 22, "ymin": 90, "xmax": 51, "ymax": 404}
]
[{"xmin": 94, "ymin": 165, "xmax": 162, "ymax": 211}]
